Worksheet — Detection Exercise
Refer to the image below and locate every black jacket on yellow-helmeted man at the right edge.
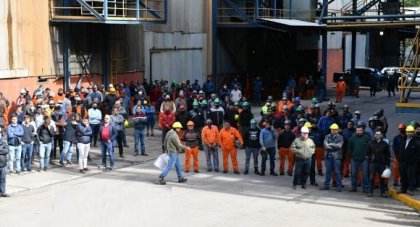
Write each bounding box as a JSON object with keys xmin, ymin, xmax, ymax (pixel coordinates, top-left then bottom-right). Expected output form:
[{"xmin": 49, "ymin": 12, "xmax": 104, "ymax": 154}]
[{"xmin": 394, "ymin": 137, "xmax": 420, "ymax": 163}]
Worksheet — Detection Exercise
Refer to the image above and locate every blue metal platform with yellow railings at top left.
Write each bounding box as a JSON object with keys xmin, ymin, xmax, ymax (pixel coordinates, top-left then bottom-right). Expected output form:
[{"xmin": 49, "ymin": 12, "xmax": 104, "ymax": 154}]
[{"xmin": 50, "ymin": 0, "xmax": 168, "ymax": 24}]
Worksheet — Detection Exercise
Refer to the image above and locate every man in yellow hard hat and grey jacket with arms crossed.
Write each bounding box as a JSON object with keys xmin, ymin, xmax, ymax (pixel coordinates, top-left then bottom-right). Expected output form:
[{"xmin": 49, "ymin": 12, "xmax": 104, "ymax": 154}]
[{"xmin": 320, "ymin": 123, "xmax": 344, "ymax": 192}]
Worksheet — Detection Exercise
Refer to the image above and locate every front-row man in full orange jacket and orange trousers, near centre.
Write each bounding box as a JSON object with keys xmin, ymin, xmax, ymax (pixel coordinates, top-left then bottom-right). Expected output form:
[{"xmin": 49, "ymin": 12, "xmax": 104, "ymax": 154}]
[{"xmin": 219, "ymin": 121, "xmax": 244, "ymax": 174}]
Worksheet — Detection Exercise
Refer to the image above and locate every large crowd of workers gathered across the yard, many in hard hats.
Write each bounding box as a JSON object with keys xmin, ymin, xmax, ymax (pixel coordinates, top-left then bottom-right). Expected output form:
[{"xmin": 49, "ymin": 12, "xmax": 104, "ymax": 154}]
[{"xmin": 0, "ymin": 77, "xmax": 420, "ymax": 197}]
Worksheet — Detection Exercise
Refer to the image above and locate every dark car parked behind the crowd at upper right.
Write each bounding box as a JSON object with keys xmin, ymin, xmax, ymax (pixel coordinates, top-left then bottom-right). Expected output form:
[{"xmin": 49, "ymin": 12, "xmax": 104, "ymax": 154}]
[{"xmin": 333, "ymin": 67, "xmax": 386, "ymax": 91}]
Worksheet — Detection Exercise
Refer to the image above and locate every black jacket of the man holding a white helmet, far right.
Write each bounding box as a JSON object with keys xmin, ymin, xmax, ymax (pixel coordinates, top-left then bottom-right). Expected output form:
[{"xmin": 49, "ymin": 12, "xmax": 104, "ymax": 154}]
[{"xmin": 366, "ymin": 140, "xmax": 391, "ymax": 166}]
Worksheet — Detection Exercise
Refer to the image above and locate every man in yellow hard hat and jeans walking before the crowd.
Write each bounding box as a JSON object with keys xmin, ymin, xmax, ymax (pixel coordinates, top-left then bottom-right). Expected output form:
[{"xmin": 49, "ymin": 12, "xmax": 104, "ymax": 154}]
[{"xmin": 159, "ymin": 122, "xmax": 191, "ymax": 185}]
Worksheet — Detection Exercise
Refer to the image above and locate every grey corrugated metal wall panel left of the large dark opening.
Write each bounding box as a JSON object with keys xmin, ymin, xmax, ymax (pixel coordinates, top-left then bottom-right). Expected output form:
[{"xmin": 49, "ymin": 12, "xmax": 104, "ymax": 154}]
[{"xmin": 144, "ymin": 0, "xmax": 210, "ymax": 82}]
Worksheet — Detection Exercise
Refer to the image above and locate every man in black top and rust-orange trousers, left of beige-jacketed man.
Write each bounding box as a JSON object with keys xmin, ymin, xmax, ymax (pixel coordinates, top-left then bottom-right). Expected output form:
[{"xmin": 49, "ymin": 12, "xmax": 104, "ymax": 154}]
[{"xmin": 277, "ymin": 120, "xmax": 296, "ymax": 176}]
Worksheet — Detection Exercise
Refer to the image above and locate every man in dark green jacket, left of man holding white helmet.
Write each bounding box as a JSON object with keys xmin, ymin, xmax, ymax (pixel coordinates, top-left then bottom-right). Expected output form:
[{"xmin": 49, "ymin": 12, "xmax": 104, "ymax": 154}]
[{"xmin": 348, "ymin": 124, "xmax": 371, "ymax": 193}]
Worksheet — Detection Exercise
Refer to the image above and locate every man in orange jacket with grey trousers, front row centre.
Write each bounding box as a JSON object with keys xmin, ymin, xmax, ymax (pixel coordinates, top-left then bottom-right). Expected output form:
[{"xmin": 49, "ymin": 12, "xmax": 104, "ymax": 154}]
[{"xmin": 201, "ymin": 119, "xmax": 219, "ymax": 172}]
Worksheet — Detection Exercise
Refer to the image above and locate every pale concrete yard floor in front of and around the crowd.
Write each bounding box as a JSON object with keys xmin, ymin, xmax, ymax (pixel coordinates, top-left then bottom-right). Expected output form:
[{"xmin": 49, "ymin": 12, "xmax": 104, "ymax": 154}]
[{"xmin": 0, "ymin": 88, "xmax": 420, "ymax": 226}]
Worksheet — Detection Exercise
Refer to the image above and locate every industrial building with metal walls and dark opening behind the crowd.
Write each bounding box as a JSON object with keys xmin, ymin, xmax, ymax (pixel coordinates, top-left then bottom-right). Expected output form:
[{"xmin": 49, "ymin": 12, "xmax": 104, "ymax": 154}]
[{"xmin": 0, "ymin": 0, "xmax": 419, "ymax": 107}]
